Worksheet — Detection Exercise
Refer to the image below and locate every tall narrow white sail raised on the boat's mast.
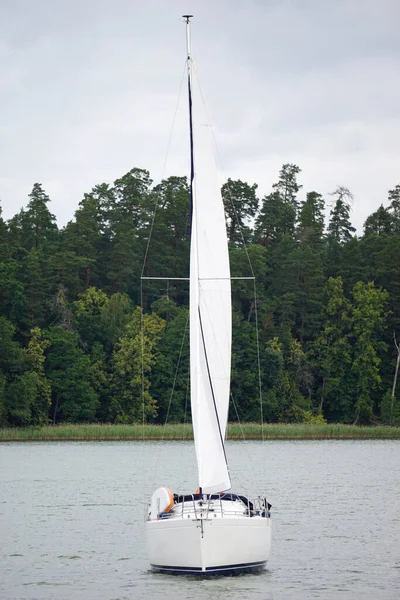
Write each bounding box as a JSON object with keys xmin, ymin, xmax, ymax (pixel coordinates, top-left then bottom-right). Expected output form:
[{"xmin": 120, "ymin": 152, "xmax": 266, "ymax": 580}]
[{"xmin": 189, "ymin": 61, "xmax": 232, "ymax": 493}]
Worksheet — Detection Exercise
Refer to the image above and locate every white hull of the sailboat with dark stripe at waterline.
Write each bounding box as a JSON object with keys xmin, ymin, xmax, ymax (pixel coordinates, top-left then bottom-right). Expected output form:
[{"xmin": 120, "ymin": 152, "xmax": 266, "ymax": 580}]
[{"xmin": 146, "ymin": 496, "xmax": 271, "ymax": 575}]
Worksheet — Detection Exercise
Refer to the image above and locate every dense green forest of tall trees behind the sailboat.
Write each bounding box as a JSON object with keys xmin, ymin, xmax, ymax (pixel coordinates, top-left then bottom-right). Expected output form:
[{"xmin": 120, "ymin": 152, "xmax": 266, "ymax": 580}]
[{"xmin": 0, "ymin": 164, "xmax": 400, "ymax": 426}]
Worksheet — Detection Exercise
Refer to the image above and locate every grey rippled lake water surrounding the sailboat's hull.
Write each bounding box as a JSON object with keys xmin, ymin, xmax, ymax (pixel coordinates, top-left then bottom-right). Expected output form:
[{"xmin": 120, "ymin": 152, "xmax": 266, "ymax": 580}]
[{"xmin": 0, "ymin": 440, "xmax": 400, "ymax": 600}]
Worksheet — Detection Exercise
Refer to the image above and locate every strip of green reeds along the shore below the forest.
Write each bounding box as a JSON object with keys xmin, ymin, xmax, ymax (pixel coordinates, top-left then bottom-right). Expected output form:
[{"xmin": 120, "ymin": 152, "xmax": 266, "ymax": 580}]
[{"xmin": 0, "ymin": 423, "xmax": 400, "ymax": 442}]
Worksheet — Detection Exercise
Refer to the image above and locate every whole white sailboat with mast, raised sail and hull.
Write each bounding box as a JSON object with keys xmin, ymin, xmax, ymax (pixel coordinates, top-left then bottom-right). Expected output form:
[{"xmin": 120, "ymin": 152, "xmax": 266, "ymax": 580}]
[{"xmin": 145, "ymin": 15, "xmax": 271, "ymax": 575}]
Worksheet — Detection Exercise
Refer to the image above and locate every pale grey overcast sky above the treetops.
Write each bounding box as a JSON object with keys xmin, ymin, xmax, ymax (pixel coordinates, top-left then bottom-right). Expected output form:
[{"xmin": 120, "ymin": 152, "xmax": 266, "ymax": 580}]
[{"xmin": 0, "ymin": 0, "xmax": 400, "ymax": 233}]
